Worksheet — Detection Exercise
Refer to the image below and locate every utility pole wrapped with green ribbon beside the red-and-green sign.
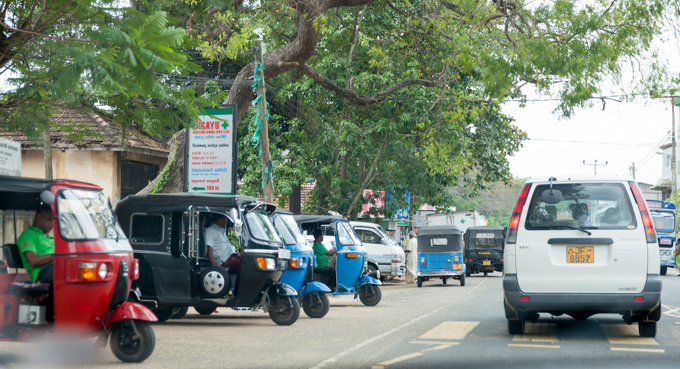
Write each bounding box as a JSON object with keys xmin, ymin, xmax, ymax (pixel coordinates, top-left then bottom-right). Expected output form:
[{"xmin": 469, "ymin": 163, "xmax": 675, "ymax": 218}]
[{"xmin": 255, "ymin": 40, "xmax": 274, "ymax": 203}]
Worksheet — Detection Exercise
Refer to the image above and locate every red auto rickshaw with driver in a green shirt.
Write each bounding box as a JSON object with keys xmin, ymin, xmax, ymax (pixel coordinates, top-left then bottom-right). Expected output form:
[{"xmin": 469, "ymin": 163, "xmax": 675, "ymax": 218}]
[{"xmin": 0, "ymin": 176, "xmax": 157, "ymax": 362}]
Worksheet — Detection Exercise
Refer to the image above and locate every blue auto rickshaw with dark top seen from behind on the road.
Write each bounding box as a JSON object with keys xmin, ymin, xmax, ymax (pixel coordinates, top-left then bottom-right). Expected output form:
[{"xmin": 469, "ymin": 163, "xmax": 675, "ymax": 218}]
[{"xmin": 416, "ymin": 226, "xmax": 465, "ymax": 287}]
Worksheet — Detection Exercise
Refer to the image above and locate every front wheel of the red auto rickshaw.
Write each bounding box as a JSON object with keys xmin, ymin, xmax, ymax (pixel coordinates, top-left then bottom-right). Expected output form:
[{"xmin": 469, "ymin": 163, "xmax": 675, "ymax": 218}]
[{"xmin": 110, "ymin": 320, "xmax": 156, "ymax": 363}]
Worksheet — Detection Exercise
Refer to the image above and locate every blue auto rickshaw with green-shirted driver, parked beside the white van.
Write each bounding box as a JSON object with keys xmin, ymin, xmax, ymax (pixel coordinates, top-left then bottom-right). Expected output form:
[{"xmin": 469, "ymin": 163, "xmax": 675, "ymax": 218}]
[{"xmin": 294, "ymin": 215, "xmax": 382, "ymax": 306}]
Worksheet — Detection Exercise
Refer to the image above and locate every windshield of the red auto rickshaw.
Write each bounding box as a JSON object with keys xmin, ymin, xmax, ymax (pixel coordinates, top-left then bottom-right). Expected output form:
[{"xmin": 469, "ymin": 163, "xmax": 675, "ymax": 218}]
[{"xmin": 57, "ymin": 189, "xmax": 126, "ymax": 240}]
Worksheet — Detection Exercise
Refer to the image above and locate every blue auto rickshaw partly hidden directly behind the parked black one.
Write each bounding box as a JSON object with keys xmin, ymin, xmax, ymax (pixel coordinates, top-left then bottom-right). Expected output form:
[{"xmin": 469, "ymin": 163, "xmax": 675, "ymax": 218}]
[{"xmin": 272, "ymin": 209, "xmax": 331, "ymax": 318}]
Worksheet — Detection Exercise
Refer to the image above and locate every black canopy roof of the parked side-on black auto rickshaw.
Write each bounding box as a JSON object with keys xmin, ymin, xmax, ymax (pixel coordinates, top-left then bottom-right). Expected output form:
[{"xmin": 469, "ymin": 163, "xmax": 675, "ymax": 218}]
[{"xmin": 116, "ymin": 192, "xmax": 257, "ymax": 213}]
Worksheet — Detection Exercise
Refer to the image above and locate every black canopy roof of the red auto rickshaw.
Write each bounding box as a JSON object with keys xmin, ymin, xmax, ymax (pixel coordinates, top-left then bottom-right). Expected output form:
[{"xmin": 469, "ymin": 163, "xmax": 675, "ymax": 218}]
[{"xmin": 0, "ymin": 176, "xmax": 98, "ymax": 211}]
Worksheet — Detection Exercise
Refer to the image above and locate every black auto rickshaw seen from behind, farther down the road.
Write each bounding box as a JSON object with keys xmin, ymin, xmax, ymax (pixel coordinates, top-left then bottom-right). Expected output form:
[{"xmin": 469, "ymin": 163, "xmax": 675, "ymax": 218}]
[{"xmin": 465, "ymin": 226, "xmax": 505, "ymax": 276}]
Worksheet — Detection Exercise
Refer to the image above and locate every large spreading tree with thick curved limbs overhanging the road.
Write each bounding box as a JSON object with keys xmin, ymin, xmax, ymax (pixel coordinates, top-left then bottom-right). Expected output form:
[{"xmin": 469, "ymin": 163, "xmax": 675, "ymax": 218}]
[{"xmin": 145, "ymin": 0, "xmax": 674, "ymax": 210}]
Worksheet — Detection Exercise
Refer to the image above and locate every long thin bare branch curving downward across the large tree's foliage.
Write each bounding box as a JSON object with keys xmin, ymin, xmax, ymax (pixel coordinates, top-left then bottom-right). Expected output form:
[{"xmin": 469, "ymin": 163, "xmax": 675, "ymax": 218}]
[{"xmin": 298, "ymin": 63, "xmax": 441, "ymax": 106}]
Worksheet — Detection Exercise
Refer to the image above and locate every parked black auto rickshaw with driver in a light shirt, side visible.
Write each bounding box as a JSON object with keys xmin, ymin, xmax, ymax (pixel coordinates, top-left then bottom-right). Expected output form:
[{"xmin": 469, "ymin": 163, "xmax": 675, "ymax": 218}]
[{"xmin": 116, "ymin": 193, "xmax": 300, "ymax": 325}]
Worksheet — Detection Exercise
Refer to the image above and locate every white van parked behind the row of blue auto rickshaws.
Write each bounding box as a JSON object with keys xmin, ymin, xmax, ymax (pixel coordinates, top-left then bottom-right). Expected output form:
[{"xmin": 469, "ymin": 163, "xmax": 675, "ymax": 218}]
[{"xmin": 349, "ymin": 222, "xmax": 406, "ymax": 277}]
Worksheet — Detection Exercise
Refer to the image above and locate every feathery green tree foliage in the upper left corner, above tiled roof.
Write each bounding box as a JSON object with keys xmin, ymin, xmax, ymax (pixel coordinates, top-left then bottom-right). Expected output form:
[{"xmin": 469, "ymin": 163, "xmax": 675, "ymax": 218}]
[{"xmin": 0, "ymin": 0, "xmax": 219, "ymax": 150}]
